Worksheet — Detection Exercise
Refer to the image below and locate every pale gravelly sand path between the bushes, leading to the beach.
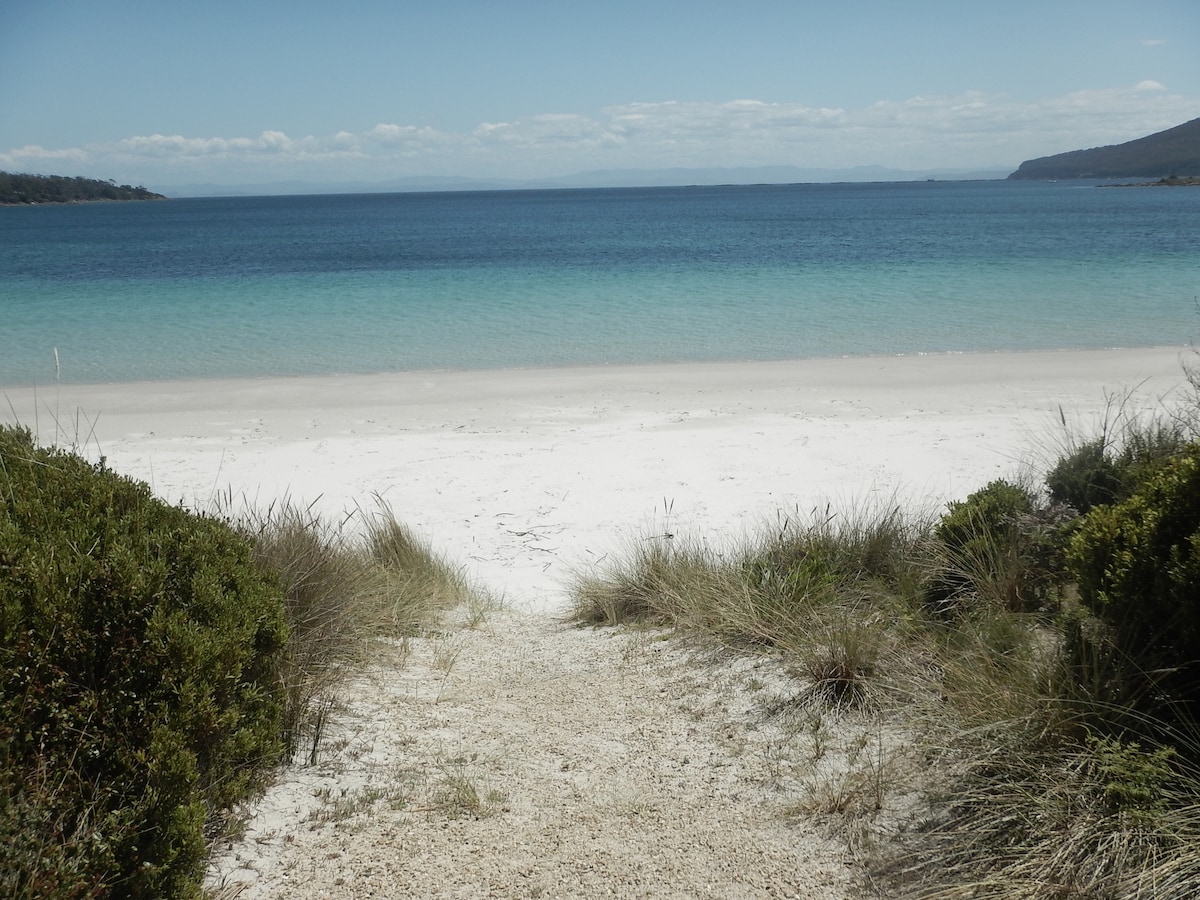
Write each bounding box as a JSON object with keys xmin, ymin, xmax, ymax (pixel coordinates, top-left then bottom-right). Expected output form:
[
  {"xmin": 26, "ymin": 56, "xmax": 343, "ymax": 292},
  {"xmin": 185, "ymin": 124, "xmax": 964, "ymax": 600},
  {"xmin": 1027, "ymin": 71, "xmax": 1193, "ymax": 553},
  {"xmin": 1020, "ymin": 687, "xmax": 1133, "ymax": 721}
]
[{"xmin": 211, "ymin": 611, "xmax": 853, "ymax": 899}]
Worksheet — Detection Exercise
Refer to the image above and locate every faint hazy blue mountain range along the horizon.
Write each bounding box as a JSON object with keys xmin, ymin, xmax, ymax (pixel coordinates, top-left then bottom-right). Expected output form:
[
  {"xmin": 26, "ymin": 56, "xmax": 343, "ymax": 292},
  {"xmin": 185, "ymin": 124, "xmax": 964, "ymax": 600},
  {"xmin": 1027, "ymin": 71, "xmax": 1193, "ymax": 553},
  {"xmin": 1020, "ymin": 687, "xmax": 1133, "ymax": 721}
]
[{"xmin": 162, "ymin": 166, "xmax": 1007, "ymax": 197}]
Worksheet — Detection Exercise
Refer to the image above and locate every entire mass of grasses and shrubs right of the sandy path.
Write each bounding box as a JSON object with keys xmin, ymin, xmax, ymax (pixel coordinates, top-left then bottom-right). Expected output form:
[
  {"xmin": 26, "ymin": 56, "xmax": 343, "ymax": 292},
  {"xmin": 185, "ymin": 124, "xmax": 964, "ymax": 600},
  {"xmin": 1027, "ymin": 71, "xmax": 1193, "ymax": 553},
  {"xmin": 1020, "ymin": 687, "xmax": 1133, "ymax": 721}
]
[{"xmin": 572, "ymin": 364, "xmax": 1200, "ymax": 899}]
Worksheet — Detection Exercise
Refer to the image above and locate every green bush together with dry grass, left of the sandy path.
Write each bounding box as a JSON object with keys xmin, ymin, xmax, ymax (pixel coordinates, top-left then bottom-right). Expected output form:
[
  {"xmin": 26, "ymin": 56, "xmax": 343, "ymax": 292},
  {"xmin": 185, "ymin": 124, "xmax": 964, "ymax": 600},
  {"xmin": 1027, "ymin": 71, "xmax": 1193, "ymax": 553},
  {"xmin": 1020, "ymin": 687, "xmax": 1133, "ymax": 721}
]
[{"xmin": 0, "ymin": 426, "xmax": 479, "ymax": 900}]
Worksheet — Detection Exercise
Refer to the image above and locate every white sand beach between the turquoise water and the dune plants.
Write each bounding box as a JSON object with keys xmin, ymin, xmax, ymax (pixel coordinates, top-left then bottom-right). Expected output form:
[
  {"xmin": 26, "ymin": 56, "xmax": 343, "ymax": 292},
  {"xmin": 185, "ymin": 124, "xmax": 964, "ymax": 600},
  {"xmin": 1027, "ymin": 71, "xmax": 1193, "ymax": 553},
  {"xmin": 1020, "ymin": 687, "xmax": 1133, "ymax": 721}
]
[{"xmin": 2, "ymin": 347, "xmax": 1192, "ymax": 610}]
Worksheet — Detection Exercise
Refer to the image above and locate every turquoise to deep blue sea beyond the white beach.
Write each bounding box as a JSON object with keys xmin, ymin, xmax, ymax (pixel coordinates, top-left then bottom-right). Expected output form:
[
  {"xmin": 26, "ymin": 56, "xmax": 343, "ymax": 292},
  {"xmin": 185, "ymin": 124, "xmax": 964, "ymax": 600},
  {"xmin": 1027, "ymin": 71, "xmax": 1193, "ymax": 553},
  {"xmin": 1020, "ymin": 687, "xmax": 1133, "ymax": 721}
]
[{"xmin": 0, "ymin": 181, "xmax": 1200, "ymax": 386}]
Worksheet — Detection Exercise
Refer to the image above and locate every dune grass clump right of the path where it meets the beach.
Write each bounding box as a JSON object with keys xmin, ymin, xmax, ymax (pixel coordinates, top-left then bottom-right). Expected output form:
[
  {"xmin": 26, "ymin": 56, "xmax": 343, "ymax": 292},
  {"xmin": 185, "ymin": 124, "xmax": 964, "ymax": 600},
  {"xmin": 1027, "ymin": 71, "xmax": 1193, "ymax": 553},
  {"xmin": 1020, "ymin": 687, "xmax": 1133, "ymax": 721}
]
[{"xmin": 572, "ymin": 508, "xmax": 924, "ymax": 706}]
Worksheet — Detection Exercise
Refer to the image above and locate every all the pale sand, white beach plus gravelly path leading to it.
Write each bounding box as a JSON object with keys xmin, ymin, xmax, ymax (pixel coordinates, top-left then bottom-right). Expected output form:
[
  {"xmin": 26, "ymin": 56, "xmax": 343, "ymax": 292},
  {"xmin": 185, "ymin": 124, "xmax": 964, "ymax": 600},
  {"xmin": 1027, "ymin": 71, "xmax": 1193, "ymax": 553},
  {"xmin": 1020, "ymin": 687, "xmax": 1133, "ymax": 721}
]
[{"xmin": 6, "ymin": 348, "xmax": 1190, "ymax": 898}]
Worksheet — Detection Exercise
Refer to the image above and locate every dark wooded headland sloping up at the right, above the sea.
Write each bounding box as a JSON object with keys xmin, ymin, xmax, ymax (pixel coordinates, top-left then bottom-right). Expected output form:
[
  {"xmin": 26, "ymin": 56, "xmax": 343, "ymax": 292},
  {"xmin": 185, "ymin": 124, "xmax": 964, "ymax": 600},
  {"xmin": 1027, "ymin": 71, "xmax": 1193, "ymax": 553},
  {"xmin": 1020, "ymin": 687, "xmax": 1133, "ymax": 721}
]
[{"xmin": 1009, "ymin": 119, "xmax": 1200, "ymax": 181}]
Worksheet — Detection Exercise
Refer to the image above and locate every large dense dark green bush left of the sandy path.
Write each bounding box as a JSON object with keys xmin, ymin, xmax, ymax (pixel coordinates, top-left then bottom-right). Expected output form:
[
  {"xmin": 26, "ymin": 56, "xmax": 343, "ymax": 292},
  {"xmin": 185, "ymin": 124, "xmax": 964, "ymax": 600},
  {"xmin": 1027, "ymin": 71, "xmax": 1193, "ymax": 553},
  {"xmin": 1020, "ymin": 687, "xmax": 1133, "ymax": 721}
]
[{"xmin": 0, "ymin": 426, "xmax": 287, "ymax": 898}]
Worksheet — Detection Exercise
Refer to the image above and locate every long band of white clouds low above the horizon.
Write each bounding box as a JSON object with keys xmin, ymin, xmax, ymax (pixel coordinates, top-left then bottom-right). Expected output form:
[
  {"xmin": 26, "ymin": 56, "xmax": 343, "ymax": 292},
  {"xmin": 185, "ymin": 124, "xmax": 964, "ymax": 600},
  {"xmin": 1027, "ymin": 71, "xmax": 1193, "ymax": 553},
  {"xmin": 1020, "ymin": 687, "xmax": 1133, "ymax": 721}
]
[{"xmin": 0, "ymin": 80, "xmax": 1200, "ymax": 186}]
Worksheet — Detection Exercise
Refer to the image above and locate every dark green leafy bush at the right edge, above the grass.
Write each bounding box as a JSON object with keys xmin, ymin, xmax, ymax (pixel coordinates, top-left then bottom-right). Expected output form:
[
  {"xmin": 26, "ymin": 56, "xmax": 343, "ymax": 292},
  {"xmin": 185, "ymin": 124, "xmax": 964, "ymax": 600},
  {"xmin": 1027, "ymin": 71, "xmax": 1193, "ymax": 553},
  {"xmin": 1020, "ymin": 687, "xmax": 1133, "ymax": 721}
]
[{"xmin": 1068, "ymin": 444, "xmax": 1200, "ymax": 712}]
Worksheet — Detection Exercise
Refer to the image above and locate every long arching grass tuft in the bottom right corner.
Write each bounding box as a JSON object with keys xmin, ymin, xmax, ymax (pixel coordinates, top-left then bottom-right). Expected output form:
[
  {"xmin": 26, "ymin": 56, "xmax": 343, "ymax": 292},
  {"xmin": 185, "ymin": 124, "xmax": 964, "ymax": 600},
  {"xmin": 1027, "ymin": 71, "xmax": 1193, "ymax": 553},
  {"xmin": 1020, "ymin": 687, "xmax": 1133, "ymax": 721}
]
[{"xmin": 883, "ymin": 724, "xmax": 1200, "ymax": 900}]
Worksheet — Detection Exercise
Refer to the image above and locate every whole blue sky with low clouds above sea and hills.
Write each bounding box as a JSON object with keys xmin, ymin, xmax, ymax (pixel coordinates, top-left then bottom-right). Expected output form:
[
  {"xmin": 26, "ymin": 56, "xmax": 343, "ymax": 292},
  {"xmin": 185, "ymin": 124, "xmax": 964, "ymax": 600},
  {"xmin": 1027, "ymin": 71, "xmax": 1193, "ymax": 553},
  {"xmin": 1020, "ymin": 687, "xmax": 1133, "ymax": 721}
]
[{"xmin": 0, "ymin": 0, "xmax": 1200, "ymax": 190}]
